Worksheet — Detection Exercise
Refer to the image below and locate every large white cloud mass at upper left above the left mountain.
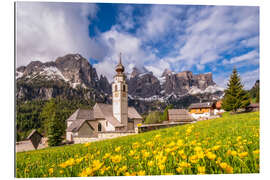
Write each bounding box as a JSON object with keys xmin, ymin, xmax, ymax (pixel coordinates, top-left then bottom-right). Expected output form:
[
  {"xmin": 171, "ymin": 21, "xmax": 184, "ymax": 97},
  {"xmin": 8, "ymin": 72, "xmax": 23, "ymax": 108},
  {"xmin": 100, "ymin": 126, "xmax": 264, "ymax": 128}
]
[{"xmin": 16, "ymin": 2, "xmax": 98, "ymax": 66}]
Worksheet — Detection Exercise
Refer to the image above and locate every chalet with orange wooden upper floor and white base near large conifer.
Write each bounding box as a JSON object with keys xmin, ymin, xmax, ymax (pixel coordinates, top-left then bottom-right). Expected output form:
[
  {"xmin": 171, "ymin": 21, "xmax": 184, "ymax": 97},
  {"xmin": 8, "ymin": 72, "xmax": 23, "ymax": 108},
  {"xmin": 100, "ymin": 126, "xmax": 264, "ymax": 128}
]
[{"xmin": 188, "ymin": 102, "xmax": 215, "ymax": 119}]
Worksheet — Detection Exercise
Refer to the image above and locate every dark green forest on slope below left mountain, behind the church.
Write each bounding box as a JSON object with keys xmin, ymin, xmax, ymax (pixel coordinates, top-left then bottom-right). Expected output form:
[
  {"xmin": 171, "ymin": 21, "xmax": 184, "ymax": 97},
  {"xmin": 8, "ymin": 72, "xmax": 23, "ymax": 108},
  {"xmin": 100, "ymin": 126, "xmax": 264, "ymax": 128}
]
[{"xmin": 16, "ymin": 97, "xmax": 94, "ymax": 141}]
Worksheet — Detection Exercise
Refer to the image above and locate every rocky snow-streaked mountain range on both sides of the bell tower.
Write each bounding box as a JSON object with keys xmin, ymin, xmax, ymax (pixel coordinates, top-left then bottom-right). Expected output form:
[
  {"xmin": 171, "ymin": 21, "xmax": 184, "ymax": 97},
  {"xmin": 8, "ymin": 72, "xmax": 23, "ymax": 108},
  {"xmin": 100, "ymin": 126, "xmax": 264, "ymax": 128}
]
[{"xmin": 16, "ymin": 54, "xmax": 223, "ymax": 113}]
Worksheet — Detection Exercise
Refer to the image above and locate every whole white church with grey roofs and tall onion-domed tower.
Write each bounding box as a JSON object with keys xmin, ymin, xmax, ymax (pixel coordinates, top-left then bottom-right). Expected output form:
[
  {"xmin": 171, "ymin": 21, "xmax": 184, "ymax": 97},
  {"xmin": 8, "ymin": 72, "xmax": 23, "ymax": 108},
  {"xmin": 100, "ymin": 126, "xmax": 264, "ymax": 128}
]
[{"xmin": 66, "ymin": 55, "xmax": 143, "ymax": 143}]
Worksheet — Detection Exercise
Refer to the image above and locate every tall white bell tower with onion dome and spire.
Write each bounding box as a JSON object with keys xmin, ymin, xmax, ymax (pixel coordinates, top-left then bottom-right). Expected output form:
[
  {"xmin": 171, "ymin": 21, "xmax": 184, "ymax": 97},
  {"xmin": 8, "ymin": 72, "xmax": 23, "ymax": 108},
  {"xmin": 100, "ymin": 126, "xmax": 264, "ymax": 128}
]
[{"xmin": 112, "ymin": 53, "xmax": 128, "ymax": 129}]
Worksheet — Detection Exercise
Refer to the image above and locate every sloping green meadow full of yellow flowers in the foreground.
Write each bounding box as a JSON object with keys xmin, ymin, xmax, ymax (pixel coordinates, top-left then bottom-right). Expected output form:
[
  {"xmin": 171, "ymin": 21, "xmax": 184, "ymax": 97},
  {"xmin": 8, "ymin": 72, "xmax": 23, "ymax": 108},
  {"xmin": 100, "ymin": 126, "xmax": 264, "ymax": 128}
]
[{"xmin": 16, "ymin": 112, "xmax": 260, "ymax": 178}]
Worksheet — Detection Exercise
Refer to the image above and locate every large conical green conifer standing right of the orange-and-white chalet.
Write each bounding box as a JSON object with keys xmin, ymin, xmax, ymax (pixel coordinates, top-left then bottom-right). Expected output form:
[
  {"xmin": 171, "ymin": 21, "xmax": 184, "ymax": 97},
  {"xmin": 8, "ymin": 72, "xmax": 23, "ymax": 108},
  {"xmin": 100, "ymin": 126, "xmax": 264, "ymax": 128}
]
[{"xmin": 222, "ymin": 68, "xmax": 250, "ymax": 112}]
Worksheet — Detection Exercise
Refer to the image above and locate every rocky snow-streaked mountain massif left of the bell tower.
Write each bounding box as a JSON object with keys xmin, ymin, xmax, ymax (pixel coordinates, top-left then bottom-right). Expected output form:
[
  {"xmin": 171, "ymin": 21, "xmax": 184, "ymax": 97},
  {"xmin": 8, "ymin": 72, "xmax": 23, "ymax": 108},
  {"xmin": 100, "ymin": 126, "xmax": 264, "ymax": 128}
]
[{"xmin": 16, "ymin": 54, "xmax": 111, "ymax": 102}]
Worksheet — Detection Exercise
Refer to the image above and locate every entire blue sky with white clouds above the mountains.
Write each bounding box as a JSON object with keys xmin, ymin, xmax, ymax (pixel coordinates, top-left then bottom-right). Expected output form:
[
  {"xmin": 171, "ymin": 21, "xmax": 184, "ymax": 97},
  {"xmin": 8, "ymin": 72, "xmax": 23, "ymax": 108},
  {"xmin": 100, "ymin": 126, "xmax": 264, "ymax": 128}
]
[{"xmin": 16, "ymin": 2, "xmax": 259, "ymax": 88}]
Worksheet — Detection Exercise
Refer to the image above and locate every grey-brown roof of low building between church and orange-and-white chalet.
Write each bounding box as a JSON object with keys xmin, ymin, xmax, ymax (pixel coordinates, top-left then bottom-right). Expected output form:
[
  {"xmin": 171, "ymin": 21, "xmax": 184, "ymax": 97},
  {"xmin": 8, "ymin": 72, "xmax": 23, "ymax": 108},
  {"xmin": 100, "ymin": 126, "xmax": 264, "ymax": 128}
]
[{"xmin": 168, "ymin": 109, "xmax": 194, "ymax": 123}]
